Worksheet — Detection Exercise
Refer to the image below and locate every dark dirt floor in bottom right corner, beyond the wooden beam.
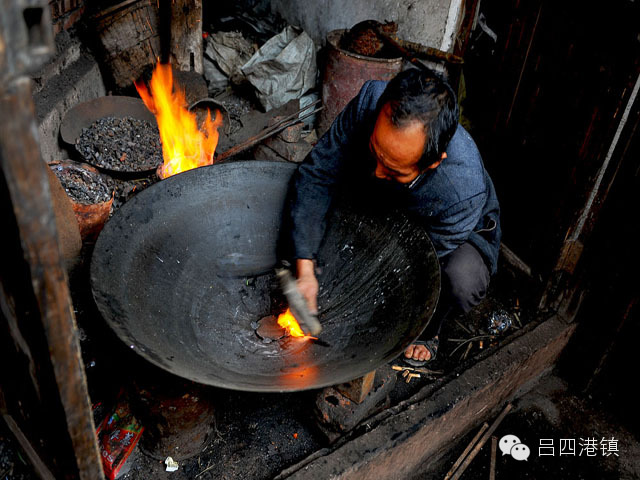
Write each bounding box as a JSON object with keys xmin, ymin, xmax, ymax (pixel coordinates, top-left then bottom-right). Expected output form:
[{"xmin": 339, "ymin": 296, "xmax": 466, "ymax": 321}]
[{"xmin": 428, "ymin": 375, "xmax": 640, "ymax": 480}]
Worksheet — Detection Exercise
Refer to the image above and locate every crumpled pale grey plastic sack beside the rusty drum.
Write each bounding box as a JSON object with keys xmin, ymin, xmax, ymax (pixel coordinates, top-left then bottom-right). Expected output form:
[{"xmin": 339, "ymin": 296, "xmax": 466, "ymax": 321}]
[{"xmin": 242, "ymin": 26, "xmax": 317, "ymax": 111}]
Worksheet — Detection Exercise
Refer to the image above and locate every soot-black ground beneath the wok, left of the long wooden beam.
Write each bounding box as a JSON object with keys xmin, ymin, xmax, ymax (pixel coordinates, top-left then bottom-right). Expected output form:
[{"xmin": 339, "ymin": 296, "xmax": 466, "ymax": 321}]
[{"xmin": 117, "ymin": 390, "xmax": 324, "ymax": 480}]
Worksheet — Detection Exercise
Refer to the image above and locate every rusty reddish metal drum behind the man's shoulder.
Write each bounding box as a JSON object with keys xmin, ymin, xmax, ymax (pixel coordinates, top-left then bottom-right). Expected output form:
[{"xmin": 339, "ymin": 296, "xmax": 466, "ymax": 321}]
[{"xmin": 318, "ymin": 30, "xmax": 402, "ymax": 135}]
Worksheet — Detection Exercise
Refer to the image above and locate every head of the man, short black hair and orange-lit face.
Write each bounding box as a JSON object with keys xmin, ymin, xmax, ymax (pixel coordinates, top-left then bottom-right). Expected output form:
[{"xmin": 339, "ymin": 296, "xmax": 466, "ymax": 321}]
[{"xmin": 369, "ymin": 69, "xmax": 459, "ymax": 183}]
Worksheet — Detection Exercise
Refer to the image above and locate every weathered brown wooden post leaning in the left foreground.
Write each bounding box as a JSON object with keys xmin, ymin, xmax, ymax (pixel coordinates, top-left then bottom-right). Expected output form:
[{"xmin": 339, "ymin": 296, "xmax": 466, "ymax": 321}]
[{"xmin": 0, "ymin": 77, "xmax": 104, "ymax": 480}]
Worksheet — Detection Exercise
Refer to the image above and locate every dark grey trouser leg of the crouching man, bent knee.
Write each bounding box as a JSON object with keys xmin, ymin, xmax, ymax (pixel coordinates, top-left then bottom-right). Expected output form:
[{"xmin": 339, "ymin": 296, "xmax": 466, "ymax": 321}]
[{"xmin": 424, "ymin": 243, "xmax": 490, "ymax": 338}]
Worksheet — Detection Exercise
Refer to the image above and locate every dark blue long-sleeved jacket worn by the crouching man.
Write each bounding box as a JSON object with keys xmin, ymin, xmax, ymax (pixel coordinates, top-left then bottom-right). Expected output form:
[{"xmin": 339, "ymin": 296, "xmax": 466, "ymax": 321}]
[{"xmin": 291, "ymin": 81, "xmax": 501, "ymax": 273}]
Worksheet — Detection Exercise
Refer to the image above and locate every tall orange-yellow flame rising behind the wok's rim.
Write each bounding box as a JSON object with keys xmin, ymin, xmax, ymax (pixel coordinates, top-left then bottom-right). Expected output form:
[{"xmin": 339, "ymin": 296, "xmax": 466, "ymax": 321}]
[{"xmin": 136, "ymin": 63, "xmax": 222, "ymax": 178}]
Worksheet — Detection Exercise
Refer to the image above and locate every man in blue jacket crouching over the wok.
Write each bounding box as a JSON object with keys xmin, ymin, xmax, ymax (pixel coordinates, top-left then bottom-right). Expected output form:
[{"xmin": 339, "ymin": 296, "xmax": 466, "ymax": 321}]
[{"xmin": 291, "ymin": 69, "xmax": 501, "ymax": 362}]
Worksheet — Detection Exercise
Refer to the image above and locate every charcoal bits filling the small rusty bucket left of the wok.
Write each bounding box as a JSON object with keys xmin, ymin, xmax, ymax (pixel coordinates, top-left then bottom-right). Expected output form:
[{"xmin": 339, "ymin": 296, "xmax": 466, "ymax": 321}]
[{"xmin": 51, "ymin": 164, "xmax": 112, "ymax": 205}]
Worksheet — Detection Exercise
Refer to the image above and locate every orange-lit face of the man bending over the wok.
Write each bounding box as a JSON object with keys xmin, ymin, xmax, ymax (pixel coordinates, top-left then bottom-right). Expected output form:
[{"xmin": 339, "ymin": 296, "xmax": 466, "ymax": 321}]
[{"xmin": 369, "ymin": 105, "xmax": 427, "ymax": 183}]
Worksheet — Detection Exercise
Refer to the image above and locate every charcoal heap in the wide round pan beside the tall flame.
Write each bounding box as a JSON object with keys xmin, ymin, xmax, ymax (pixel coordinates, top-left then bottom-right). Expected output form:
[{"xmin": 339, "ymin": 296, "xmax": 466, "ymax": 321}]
[{"xmin": 76, "ymin": 117, "xmax": 162, "ymax": 172}]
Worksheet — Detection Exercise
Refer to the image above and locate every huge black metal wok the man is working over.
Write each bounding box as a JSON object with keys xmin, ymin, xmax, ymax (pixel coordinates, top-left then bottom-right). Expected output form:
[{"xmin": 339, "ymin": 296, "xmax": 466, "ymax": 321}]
[{"xmin": 91, "ymin": 161, "xmax": 440, "ymax": 391}]
